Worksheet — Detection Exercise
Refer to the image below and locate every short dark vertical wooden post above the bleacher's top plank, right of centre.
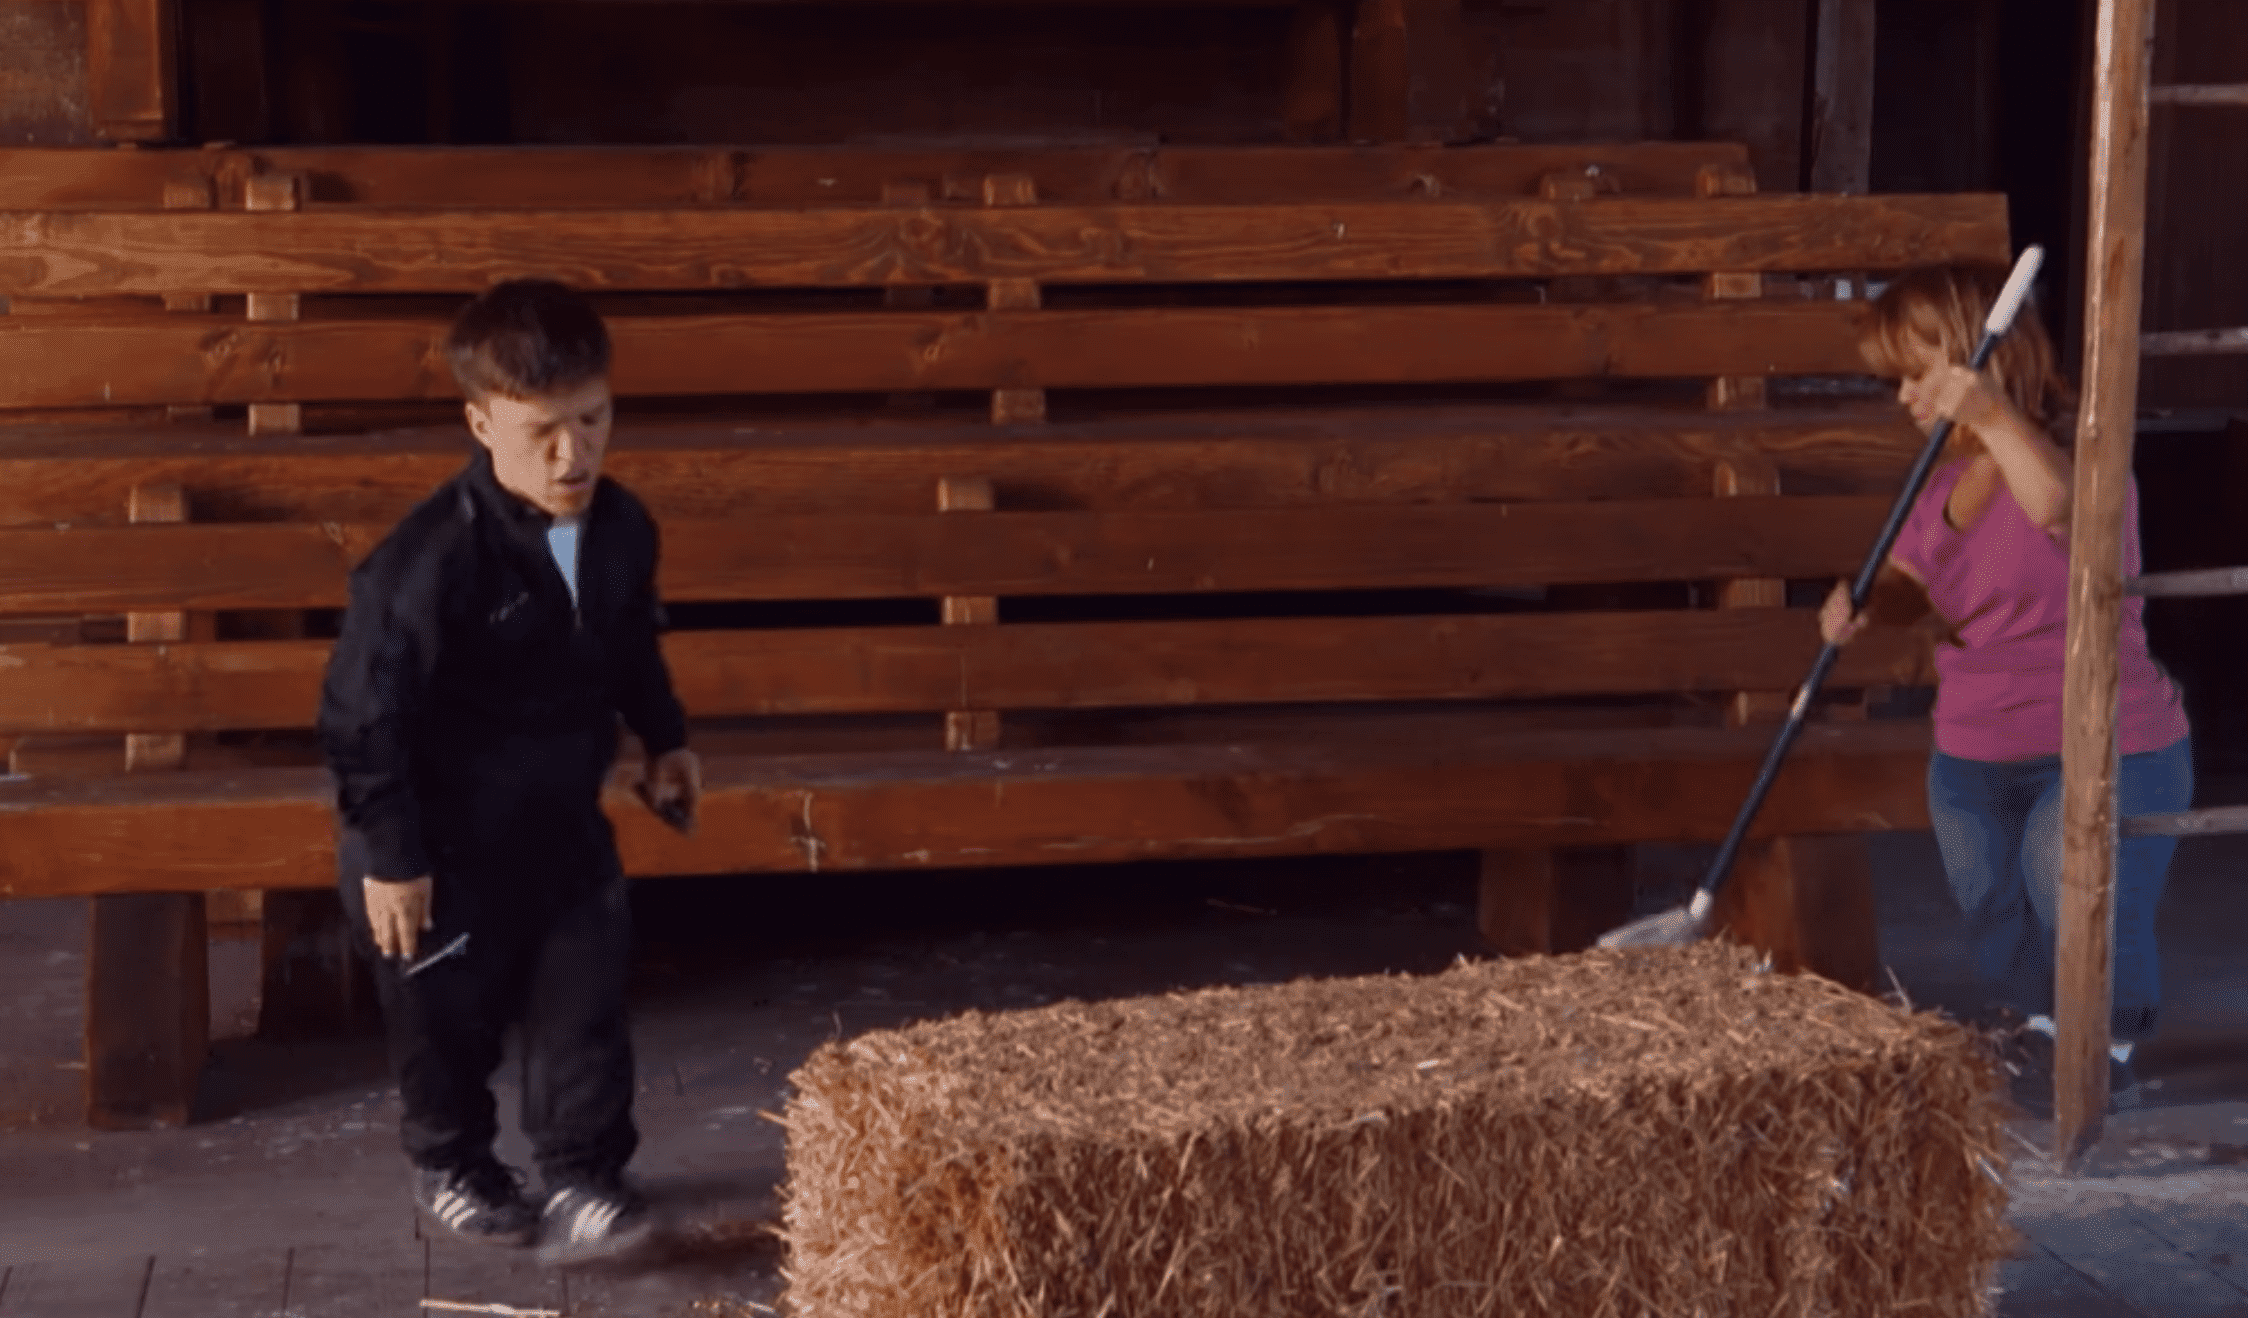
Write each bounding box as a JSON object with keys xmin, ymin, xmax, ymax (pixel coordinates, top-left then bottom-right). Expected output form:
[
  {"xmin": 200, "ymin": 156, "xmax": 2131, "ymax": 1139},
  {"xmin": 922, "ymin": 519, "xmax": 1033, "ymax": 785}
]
[{"xmin": 1349, "ymin": 0, "xmax": 1475, "ymax": 142}]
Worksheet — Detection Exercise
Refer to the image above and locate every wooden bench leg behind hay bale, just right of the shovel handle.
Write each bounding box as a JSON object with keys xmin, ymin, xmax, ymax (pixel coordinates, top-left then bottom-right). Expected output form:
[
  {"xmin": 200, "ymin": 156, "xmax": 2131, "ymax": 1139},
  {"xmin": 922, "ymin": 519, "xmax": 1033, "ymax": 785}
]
[{"xmin": 1715, "ymin": 832, "xmax": 1882, "ymax": 992}]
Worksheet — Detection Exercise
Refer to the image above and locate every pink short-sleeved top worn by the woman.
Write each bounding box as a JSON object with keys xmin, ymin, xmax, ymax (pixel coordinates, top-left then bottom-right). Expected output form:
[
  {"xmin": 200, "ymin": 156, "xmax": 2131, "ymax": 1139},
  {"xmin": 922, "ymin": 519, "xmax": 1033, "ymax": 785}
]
[{"xmin": 1891, "ymin": 461, "xmax": 2187, "ymax": 760}]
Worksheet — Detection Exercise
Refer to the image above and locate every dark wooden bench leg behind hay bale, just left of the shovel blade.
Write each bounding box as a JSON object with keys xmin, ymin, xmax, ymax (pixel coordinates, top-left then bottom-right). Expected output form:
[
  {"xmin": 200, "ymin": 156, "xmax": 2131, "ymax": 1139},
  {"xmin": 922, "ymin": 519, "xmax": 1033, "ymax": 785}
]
[{"xmin": 1475, "ymin": 846, "xmax": 1632, "ymax": 956}]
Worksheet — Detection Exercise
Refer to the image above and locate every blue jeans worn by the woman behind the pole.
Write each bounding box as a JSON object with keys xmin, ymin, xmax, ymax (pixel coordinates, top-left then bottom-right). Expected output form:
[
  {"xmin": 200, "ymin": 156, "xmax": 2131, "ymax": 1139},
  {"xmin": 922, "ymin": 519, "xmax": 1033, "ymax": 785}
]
[{"xmin": 1929, "ymin": 738, "xmax": 2194, "ymax": 1039}]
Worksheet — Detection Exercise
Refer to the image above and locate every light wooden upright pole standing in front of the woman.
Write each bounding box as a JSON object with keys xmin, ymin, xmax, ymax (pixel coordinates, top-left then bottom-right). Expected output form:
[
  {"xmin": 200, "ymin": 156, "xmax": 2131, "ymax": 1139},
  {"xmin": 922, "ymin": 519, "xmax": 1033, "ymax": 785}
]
[{"xmin": 2052, "ymin": 0, "xmax": 2154, "ymax": 1167}]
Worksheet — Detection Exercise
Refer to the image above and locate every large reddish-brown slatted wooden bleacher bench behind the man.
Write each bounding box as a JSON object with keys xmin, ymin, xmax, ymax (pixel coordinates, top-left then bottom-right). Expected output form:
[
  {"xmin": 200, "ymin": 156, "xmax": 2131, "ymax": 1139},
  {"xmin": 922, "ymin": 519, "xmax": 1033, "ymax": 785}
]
[{"xmin": 0, "ymin": 144, "xmax": 2007, "ymax": 1122}]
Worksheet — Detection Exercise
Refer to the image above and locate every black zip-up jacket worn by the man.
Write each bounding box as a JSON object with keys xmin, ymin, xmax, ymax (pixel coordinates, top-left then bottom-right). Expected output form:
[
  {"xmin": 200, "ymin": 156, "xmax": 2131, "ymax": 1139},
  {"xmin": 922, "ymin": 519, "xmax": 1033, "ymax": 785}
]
[{"xmin": 319, "ymin": 450, "xmax": 686, "ymax": 879}]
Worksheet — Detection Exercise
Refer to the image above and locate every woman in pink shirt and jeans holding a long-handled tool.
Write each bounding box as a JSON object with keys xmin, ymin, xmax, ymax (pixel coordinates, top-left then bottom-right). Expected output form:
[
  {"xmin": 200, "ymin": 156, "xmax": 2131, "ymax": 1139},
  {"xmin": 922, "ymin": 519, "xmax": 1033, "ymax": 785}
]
[{"xmin": 1819, "ymin": 270, "xmax": 2194, "ymax": 1107}]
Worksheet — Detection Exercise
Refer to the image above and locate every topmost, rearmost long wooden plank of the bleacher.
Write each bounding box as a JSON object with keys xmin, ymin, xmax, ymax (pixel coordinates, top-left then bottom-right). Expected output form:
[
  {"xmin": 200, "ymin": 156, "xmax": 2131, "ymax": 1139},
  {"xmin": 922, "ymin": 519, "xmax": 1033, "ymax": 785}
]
[{"xmin": 0, "ymin": 142, "xmax": 1747, "ymax": 211}]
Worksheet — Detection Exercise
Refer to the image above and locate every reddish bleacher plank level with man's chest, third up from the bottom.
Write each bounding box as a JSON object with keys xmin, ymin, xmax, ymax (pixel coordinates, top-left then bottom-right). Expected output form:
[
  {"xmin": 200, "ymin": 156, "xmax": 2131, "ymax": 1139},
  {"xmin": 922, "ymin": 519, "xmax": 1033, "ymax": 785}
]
[{"xmin": 0, "ymin": 495, "xmax": 1886, "ymax": 614}]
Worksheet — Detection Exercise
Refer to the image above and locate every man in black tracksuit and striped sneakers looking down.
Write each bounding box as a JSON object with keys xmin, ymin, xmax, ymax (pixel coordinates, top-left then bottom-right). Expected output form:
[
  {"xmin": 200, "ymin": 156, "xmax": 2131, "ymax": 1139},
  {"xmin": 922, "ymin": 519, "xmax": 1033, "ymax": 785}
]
[{"xmin": 319, "ymin": 281, "xmax": 701, "ymax": 1262}]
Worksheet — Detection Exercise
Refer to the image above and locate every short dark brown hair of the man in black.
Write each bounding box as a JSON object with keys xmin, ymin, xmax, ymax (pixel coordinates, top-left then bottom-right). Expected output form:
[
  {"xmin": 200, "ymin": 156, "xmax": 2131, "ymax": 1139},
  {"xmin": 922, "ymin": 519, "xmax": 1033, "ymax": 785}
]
[{"xmin": 445, "ymin": 279, "xmax": 609, "ymax": 403}]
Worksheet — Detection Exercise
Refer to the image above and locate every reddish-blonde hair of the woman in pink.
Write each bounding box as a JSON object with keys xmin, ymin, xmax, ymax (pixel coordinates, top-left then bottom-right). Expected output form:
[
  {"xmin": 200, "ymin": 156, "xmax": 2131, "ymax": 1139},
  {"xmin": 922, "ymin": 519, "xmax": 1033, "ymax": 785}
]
[{"xmin": 1859, "ymin": 265, "xmax": 2075, "ymax": 434}]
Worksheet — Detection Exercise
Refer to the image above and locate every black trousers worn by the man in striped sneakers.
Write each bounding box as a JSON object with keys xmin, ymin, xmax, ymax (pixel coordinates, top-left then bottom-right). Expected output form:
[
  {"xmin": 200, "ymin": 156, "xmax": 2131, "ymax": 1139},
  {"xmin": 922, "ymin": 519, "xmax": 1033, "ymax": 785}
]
[{"xmin": 337, "ymin": 830, "xmax": 641, "ymax": 1185}]
